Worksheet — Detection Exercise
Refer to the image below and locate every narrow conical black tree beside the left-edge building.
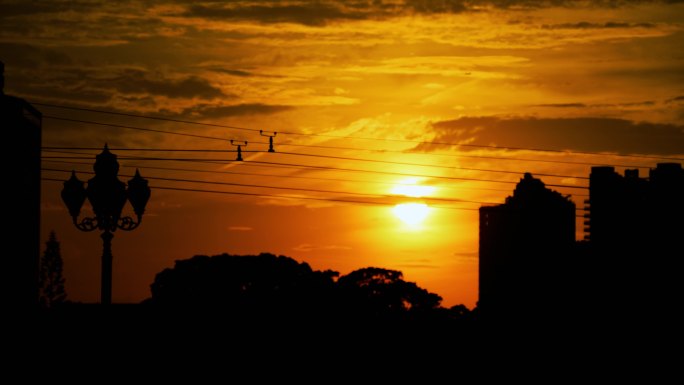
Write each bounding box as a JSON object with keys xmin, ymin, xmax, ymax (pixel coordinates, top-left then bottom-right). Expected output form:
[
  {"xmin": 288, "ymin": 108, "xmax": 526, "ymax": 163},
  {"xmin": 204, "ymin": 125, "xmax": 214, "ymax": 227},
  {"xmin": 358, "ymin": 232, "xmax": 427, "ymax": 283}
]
[{"xmin": 39, "ymin": 231, "xmax": 66, "ymax": 308}]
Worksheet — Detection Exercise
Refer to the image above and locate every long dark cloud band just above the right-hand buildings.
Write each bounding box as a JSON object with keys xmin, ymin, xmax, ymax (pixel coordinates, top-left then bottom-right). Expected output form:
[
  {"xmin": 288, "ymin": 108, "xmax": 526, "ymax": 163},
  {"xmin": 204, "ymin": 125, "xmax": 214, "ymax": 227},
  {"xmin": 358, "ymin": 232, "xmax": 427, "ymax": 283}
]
[{"xmin": 416, "ymin": 117, "xmax": 684, "ymax": 155}]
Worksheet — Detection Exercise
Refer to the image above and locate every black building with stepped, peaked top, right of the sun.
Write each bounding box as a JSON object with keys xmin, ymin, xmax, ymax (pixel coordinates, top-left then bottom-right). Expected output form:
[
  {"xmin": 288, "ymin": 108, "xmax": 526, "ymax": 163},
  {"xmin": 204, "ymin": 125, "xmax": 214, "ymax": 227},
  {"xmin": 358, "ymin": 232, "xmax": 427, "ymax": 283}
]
[{"xmin": 478, "ymin": 173, "xmax": 575, "ymax": 320}]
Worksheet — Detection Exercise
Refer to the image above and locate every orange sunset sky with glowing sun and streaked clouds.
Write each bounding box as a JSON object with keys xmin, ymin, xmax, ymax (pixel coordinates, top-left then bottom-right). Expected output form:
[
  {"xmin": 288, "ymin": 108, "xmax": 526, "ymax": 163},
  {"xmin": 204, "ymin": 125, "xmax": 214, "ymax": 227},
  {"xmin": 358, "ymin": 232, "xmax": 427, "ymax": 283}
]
[{"xmin": 0, "ymin": 0, "xmax": 684, "ymax": 308}]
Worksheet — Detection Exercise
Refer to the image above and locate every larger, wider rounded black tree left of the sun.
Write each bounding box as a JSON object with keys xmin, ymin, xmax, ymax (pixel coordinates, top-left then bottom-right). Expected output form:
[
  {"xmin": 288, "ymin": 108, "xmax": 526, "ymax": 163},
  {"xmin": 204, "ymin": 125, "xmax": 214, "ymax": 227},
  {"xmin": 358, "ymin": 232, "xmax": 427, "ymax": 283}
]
[{"xmin": 149, "ymin": 254, "xmax": 339, "ymax": 316}]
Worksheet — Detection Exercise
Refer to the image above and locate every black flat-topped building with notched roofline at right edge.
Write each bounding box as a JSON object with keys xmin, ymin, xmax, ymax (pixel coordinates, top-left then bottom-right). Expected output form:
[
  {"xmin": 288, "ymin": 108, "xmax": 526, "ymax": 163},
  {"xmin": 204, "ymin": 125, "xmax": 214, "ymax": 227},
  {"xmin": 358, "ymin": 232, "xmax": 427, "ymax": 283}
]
[{"xmin": 585, "ymin": 163, "xmax": 684, "ymax": 318}]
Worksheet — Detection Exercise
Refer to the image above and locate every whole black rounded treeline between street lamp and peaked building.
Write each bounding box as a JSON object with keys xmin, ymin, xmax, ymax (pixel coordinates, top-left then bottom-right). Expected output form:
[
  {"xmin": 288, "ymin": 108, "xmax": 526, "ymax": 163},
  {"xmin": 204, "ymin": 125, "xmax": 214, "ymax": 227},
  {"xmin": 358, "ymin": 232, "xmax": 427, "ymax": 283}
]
[{"xmin": 143, "ymin": 253, "xmax": 475, "ymax": 324}]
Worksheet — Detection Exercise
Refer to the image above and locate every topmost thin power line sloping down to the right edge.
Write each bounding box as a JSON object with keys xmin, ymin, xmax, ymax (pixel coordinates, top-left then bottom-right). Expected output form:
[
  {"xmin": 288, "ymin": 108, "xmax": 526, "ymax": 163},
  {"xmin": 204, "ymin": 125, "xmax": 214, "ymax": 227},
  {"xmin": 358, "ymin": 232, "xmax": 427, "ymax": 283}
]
[{"xmin": 38, "ymin": 103, "xmax": 684, "ymax": 161}]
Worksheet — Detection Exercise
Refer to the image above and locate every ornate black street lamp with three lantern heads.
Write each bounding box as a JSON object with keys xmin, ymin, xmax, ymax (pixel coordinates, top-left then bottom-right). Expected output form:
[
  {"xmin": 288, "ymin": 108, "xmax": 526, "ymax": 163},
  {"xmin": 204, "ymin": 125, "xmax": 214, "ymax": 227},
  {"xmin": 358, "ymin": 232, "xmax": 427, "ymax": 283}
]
[{"xmin": 62, "ymin": 144, "xmax": 150, "ymax": 305}]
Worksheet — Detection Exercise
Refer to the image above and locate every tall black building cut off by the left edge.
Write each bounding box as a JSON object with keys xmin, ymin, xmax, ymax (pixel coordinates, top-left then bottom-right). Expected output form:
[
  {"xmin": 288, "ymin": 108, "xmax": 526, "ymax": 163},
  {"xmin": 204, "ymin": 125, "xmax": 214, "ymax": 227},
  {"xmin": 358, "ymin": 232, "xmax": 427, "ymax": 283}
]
[{"xmin": 0, "ymin": 62, "xmax": 42, "ymax": 310}]
